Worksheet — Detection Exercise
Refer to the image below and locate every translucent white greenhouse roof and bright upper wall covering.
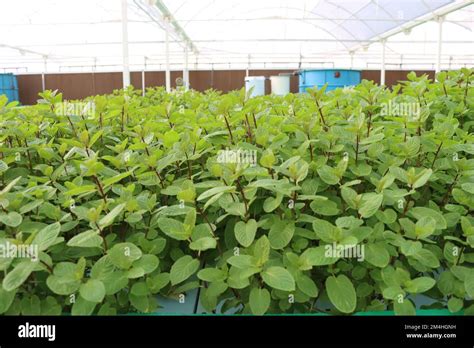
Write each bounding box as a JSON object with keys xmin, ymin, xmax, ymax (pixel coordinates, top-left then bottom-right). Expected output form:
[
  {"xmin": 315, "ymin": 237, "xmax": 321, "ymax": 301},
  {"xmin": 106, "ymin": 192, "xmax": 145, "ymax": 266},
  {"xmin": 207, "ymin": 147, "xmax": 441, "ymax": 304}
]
[{"xmin": 0, "ymin": 0, "xmax": 474, "ymax": 73}]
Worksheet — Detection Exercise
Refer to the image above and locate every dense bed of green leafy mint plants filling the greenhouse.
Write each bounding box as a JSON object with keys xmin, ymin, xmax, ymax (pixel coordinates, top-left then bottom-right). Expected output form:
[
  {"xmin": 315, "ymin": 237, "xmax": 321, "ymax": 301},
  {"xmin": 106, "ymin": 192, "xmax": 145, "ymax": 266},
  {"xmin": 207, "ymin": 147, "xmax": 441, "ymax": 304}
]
[{"xmin": 0, "ymin": 69, "xmax": 474, "ymax": 315}]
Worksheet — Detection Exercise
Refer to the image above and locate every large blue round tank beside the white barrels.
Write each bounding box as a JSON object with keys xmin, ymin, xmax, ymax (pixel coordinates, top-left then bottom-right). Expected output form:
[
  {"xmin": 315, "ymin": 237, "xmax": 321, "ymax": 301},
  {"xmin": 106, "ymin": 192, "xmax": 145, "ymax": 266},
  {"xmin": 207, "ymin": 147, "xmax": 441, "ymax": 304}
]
[{"xmin": 299, "ymin": 69, "xmax": 360, "ymax": 93}]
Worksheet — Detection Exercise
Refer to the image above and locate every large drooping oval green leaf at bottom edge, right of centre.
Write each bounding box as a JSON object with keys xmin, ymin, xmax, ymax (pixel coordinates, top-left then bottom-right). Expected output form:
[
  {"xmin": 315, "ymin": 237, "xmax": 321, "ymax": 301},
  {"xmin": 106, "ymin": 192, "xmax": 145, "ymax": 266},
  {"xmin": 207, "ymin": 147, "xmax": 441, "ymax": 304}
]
[{"xmin": 326, "ymin": 274, "xmax": 357, "ymax": 313}]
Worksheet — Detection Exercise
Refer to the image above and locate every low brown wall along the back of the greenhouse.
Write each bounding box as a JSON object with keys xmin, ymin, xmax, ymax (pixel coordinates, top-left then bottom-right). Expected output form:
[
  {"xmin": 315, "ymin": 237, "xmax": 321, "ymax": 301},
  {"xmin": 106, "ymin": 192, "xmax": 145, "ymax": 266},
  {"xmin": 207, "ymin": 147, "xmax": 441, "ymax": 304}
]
[{"xmin": 18, "ymin": 70, "xmax": 434, "ymax": 105}]
